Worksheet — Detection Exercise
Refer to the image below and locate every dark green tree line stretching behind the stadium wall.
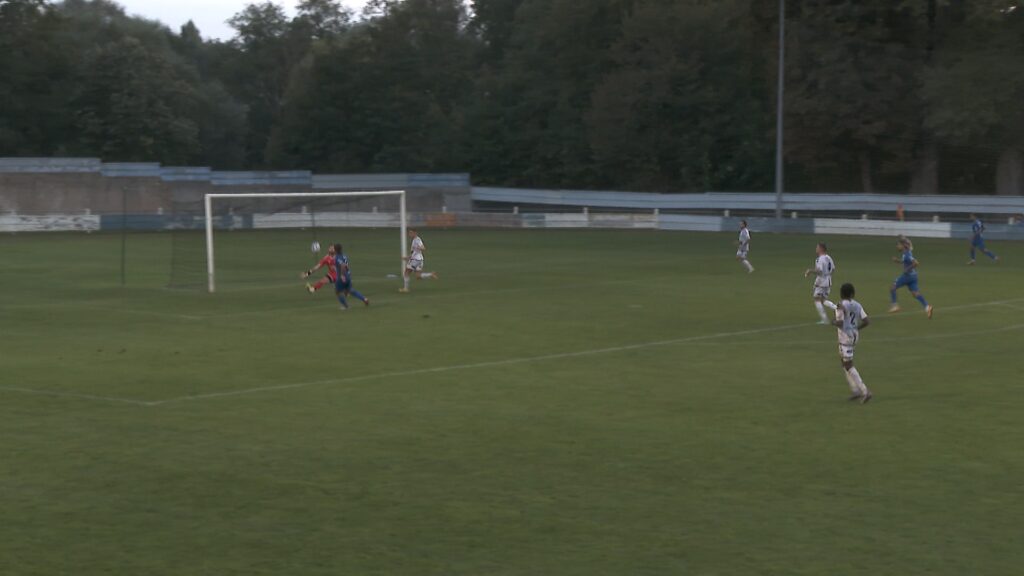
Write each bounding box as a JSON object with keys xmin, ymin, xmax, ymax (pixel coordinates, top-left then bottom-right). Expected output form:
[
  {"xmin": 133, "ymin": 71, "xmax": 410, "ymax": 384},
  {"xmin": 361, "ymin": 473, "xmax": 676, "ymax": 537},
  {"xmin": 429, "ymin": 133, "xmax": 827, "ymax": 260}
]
[{"xmin": 0, "ymin": 0, "xmax": 1024, "ymax": 194}]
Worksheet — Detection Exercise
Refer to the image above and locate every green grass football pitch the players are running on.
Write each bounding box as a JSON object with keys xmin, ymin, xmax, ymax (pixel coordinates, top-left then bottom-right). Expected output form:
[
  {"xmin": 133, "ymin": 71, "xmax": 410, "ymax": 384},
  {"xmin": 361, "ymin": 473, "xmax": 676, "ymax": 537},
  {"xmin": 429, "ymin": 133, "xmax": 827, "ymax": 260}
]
[{"xmin": 0, "ymin": 226, "xmax": 1024, "ymax": 576}]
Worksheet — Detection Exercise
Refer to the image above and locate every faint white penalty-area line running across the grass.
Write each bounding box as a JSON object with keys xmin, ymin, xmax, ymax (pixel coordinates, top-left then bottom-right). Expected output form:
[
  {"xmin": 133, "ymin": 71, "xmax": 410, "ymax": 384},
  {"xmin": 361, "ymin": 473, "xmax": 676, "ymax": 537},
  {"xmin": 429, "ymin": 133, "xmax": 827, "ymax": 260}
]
[{"xmin": 0, "ymin": 298, "xmax": 1024, "ymax": 407}]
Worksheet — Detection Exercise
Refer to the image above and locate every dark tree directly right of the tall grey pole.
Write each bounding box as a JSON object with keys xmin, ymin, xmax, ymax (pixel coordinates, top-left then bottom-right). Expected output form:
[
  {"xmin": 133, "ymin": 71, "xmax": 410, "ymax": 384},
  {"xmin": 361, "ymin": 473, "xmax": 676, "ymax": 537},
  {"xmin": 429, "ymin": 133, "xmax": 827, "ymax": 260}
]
[{"xmin": 786, "ymin": 0, "xmax": 924, "ymax": 192}]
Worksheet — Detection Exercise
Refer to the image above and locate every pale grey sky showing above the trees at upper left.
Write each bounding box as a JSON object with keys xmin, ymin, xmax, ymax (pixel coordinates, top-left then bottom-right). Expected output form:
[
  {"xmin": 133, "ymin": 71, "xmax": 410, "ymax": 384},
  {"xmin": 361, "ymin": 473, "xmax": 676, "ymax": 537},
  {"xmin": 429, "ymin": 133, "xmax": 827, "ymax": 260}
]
[{"xmin": 116, "ymin": 0, "xmax": 366, "ymax": 40}]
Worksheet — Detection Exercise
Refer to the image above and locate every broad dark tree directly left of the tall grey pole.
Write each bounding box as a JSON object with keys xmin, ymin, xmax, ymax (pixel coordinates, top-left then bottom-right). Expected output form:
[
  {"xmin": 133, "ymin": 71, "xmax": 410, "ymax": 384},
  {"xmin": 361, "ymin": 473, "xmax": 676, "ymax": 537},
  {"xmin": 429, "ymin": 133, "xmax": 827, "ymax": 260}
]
[{"xmin": 587, "ymin": 0, "xmax": 771, "ymax": 191}]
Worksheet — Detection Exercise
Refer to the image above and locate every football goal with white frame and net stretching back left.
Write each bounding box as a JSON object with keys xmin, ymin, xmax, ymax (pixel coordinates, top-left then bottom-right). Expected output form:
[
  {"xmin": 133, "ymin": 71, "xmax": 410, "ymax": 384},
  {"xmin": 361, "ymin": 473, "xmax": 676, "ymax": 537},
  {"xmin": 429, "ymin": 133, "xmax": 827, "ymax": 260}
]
[{"xmin": 171, "ymin": 191, "xmax": 408, "ymax": 292}]
